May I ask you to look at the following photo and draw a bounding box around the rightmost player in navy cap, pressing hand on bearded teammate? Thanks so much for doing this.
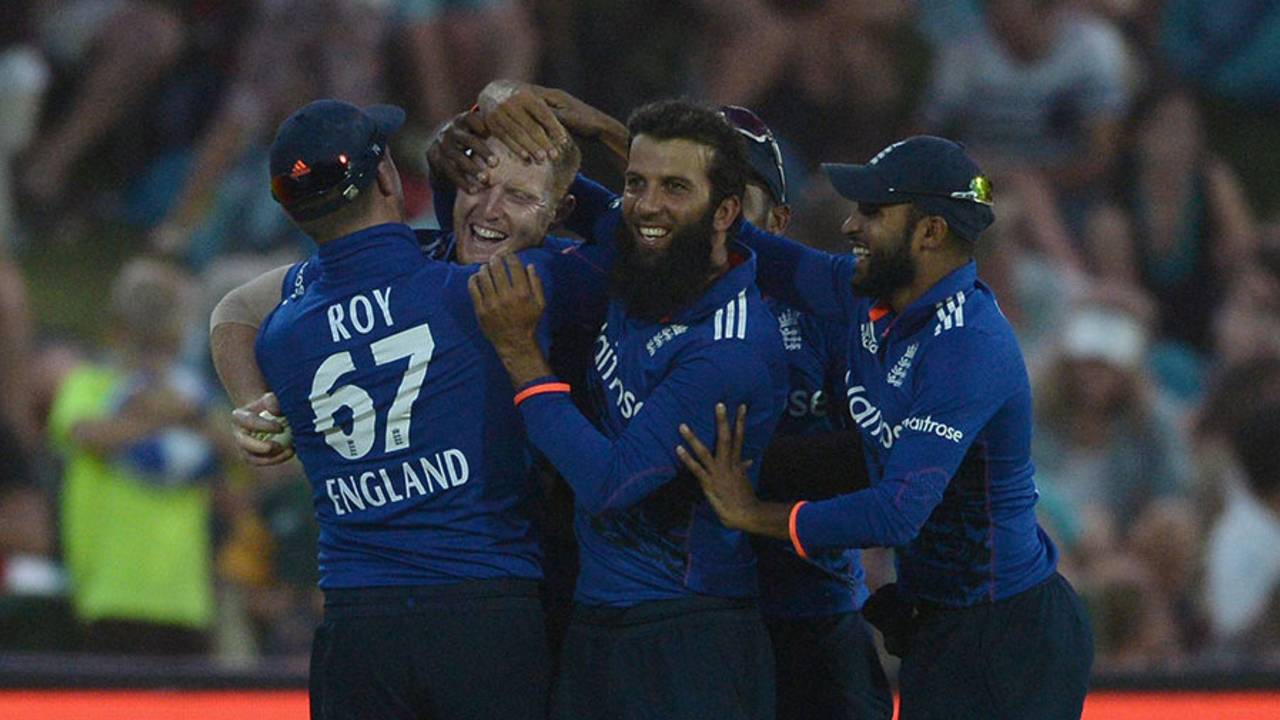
[680,136,1093,720]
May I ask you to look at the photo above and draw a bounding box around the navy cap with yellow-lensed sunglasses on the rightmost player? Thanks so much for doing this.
[822,135,996,241]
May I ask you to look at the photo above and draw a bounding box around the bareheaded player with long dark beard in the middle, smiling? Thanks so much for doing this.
[471,101,786,720]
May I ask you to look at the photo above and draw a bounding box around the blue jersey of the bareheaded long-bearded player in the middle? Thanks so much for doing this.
[521,179,786,607]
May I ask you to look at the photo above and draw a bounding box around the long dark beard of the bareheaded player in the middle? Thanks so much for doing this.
[609,210,716,323]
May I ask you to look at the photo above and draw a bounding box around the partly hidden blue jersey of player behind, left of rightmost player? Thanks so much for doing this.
[755,297,868,619]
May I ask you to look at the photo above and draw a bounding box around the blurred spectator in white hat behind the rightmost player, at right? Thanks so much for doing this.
[1032,291,1185,560]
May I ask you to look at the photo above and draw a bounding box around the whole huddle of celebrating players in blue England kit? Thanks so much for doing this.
[210,82,1092,720]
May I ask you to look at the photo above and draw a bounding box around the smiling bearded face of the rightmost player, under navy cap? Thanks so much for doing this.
[840,202,923,299]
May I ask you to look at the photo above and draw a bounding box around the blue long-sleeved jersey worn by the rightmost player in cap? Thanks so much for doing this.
[741,221,1056,607]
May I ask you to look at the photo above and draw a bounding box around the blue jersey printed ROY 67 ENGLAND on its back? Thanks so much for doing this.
[256,224,598,588]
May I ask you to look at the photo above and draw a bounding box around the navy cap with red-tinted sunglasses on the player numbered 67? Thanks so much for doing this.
[270,100,404,220]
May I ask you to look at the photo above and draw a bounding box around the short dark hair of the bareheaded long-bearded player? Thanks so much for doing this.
[627,100,750,209]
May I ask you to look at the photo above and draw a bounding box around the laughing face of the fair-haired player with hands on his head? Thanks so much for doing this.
[453,138,559,264]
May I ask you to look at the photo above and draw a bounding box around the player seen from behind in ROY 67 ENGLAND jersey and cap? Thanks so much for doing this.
[256,100,604,719]
